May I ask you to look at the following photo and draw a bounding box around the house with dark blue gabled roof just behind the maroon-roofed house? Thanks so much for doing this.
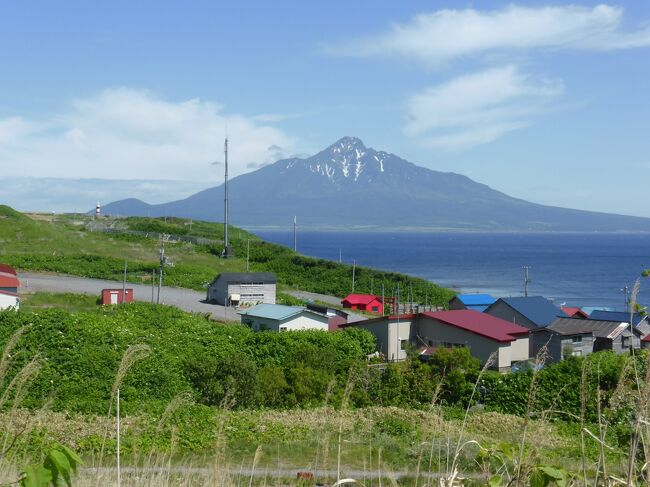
[485,296,567,329]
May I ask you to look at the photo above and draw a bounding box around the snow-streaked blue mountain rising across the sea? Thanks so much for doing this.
[104,137,650,231]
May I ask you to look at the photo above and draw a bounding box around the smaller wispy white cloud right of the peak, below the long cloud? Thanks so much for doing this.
[404,66,563,149]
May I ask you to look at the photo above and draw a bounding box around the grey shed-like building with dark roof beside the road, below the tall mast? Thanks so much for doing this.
[207,272,277,306]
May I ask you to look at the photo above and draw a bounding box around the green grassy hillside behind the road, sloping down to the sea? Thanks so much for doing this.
[0,206,453,305]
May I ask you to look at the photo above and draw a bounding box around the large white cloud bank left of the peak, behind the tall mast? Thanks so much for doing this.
[0,88,294,181]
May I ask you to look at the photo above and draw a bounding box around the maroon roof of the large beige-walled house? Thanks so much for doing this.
[422,309,529,342]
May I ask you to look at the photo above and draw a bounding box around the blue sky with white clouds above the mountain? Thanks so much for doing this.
[0,1,650,217]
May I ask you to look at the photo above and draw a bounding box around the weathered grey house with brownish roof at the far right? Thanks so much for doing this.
[530,318,641,362]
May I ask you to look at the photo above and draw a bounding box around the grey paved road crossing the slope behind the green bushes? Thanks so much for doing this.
[18,272,239,321]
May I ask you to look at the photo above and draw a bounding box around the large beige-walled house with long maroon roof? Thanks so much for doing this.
[347,310,529,371]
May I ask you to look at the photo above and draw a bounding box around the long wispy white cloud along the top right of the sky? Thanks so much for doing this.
[327,5,650,65]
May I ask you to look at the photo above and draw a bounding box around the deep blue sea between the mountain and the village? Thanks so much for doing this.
[255,231,650,310]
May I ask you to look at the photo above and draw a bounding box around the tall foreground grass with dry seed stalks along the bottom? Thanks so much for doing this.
[0,336,650,487]
